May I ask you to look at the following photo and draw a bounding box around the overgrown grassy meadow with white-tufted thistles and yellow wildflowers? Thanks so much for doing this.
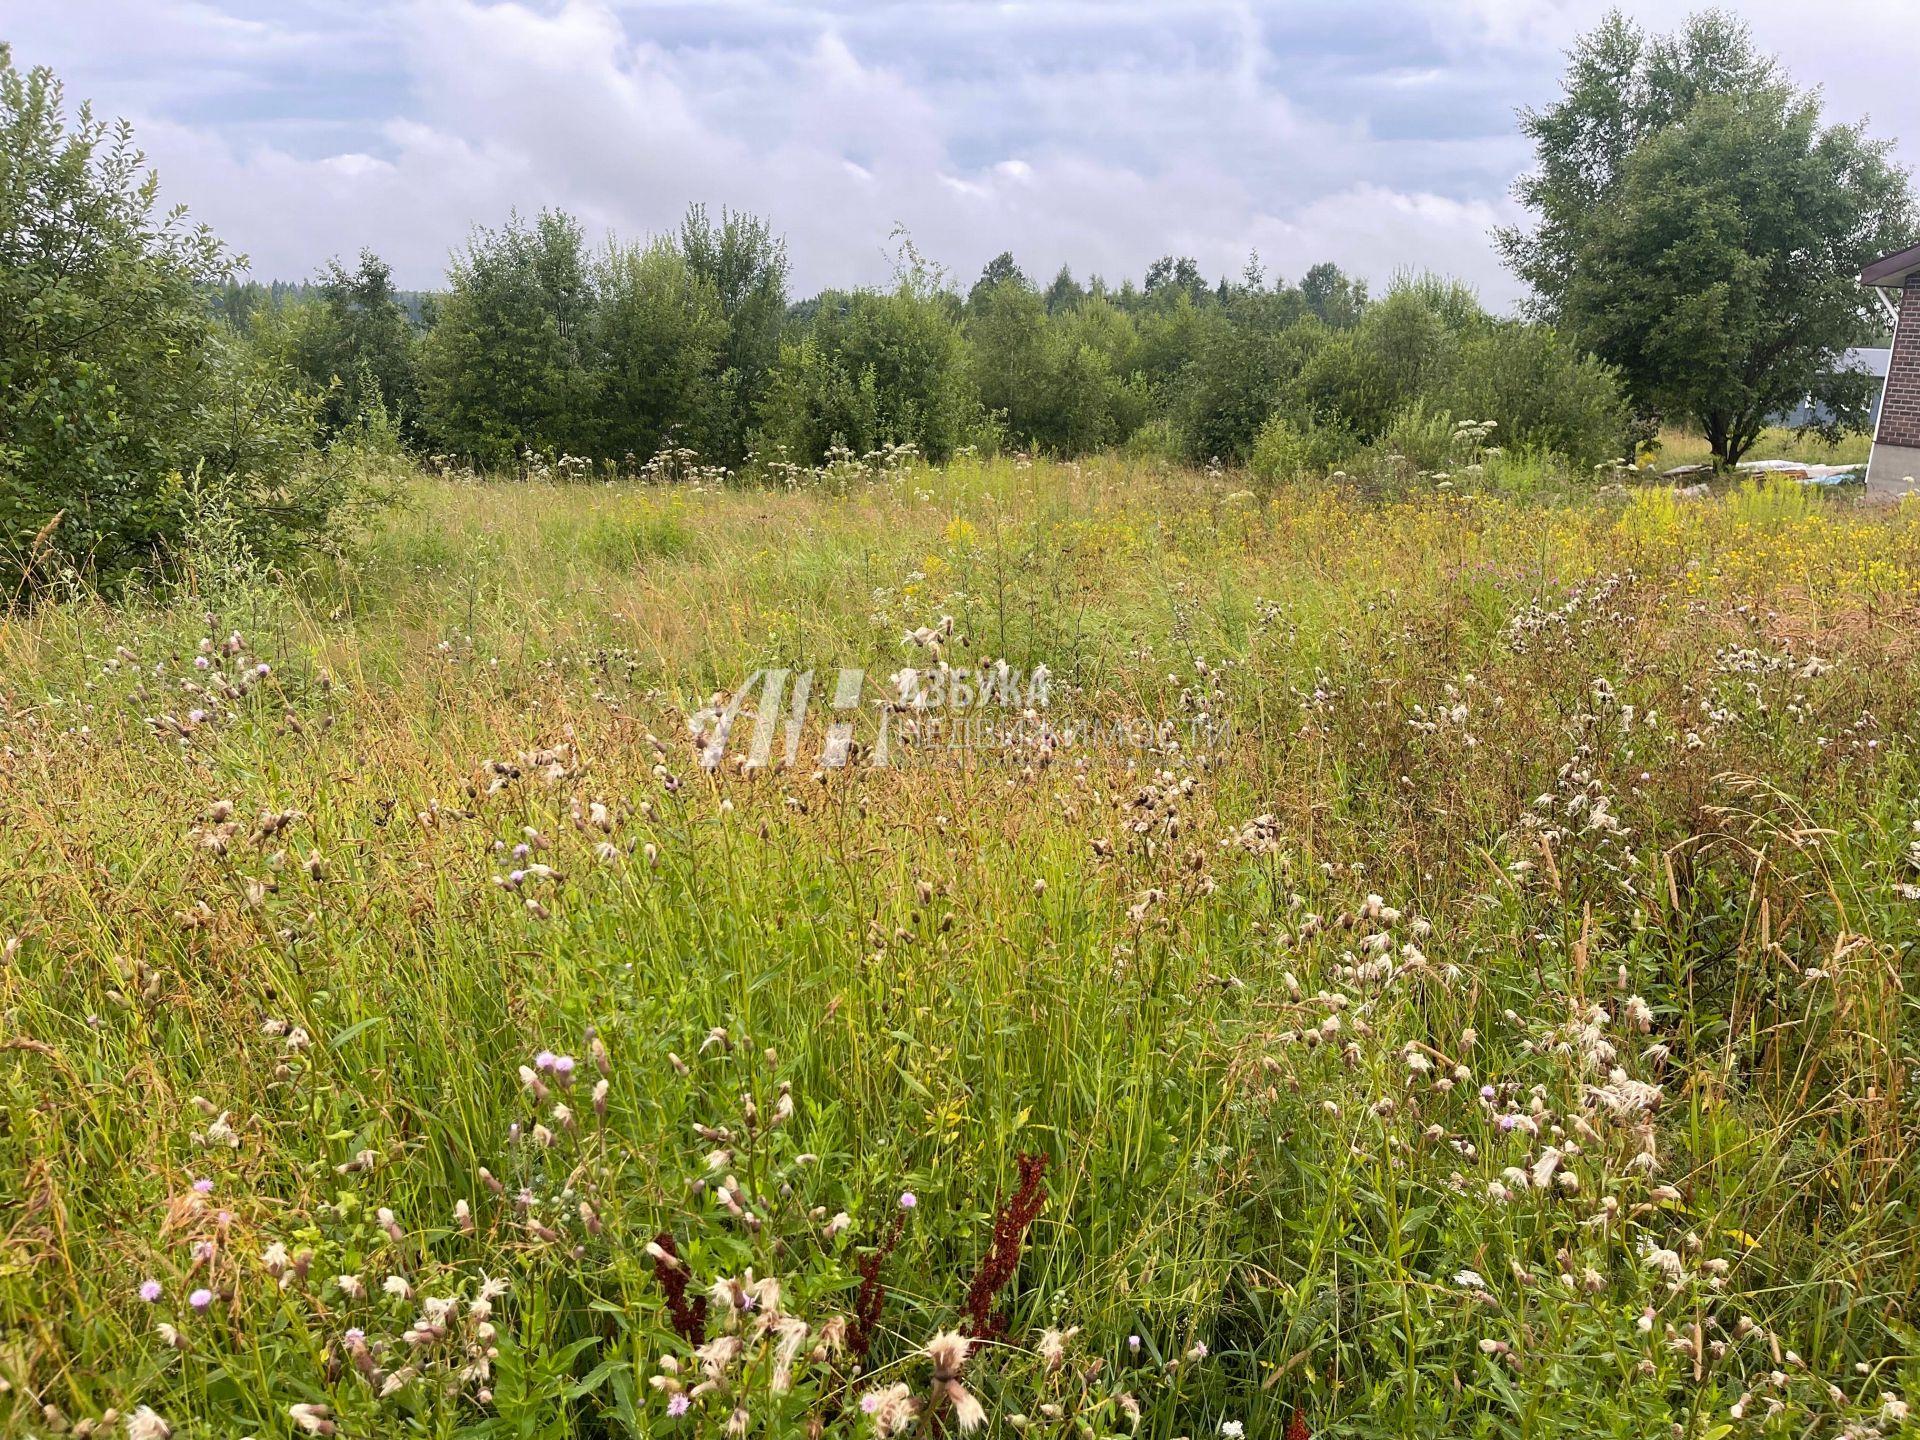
[0,461,1920,1440]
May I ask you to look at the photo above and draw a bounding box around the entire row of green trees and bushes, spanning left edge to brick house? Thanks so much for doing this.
[0,12,1914,582]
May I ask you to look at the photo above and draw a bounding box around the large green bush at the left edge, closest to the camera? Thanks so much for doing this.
[0,46,366,589]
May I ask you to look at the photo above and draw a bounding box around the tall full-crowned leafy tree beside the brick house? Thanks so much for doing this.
[1500,12,1912,465]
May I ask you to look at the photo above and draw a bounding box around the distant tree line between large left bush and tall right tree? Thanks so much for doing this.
[228,205,1626,480]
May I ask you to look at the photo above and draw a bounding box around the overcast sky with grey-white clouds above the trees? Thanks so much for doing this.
[0,0,1920,307]
